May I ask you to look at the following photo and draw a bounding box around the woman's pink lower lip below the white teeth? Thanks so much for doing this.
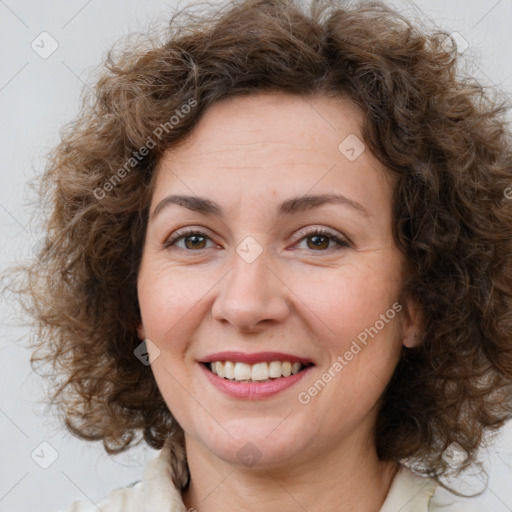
[199,363,313,400]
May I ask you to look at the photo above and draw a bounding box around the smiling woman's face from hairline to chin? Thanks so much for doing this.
[138,93,416,467]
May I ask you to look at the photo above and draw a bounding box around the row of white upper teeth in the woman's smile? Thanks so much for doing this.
[209,361,303,382]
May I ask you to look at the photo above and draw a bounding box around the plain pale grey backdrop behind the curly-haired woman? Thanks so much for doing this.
[0,0,512,512]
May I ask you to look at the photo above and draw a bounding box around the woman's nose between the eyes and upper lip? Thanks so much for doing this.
[212,242,290,333]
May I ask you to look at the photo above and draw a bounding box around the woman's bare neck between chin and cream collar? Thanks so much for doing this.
[183,439,399,512]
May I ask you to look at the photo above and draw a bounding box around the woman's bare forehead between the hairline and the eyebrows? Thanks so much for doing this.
[153,93,389,213]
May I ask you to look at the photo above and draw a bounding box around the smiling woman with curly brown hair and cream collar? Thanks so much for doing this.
[7,0,512,512]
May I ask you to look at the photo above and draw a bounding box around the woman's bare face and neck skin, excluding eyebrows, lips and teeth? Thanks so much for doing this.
[138,93,418,512]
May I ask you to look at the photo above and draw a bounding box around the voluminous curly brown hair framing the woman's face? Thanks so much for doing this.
[4,0,512,492]
